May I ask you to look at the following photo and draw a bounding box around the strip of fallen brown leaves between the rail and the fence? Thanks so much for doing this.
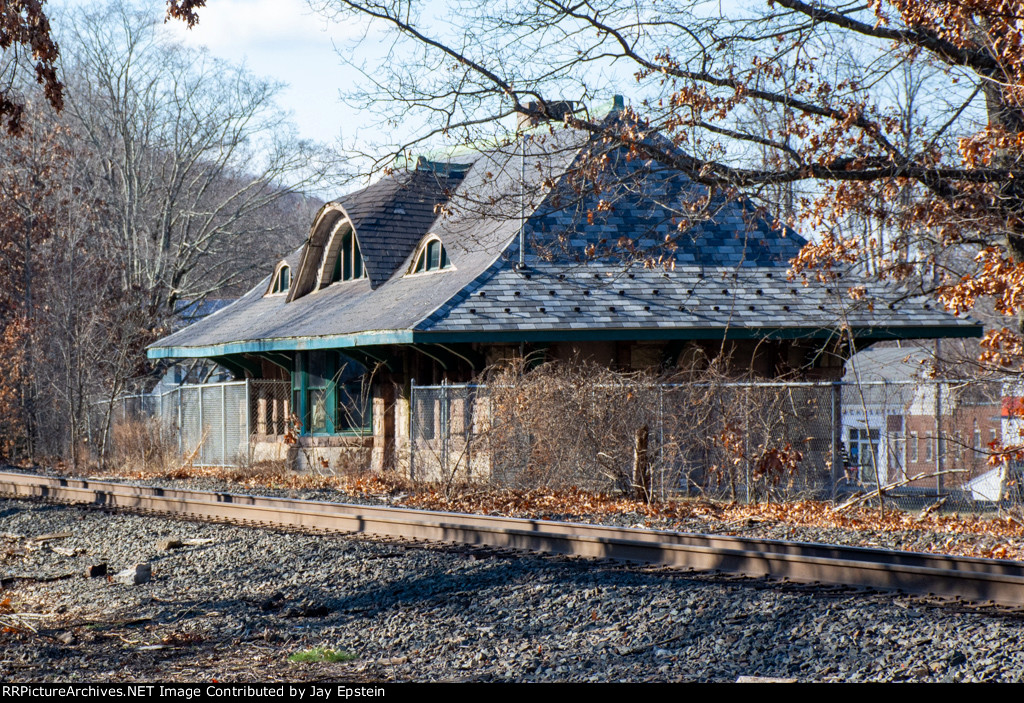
[41,467,1024,561]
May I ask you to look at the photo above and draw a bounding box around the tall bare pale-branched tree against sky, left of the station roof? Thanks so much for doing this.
[58,4,338,316]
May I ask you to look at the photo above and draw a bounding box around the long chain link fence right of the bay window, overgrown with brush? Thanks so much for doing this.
[411,376,1024,512]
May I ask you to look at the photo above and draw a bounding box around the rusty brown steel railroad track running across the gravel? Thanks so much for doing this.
[0,472,1024,608]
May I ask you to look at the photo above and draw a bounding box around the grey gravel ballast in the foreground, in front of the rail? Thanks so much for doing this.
[0,499,1024,682]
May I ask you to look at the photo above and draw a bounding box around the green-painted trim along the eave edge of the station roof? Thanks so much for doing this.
[146,324,983,359]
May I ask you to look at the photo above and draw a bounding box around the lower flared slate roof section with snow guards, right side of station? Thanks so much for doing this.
[418,262,971,335]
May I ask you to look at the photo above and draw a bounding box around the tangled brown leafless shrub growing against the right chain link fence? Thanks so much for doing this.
[475,362,830,502]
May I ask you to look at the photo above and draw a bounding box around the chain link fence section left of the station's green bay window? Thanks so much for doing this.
[89,381,291,467]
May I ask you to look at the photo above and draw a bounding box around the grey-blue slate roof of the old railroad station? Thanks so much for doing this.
[150,120,980,357]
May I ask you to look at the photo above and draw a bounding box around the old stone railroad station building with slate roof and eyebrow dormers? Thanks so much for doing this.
[148,100,981,469]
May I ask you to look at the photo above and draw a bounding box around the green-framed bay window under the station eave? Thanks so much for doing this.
[292,351,373,435]
